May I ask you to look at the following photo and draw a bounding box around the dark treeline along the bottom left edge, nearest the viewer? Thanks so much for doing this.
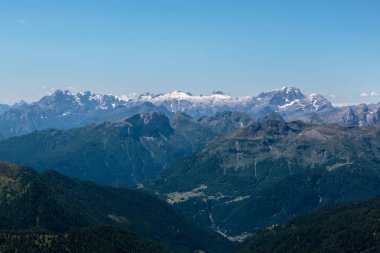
[0,226,167,253]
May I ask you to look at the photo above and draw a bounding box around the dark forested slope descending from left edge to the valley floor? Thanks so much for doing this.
[0,163,231,252]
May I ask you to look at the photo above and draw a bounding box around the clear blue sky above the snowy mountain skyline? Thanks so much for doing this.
[0,0,380,104]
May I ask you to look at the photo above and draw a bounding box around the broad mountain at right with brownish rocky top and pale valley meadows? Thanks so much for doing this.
[148,114,380,240]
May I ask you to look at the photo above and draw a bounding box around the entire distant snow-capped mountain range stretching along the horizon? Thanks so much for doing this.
[0,87,380,138]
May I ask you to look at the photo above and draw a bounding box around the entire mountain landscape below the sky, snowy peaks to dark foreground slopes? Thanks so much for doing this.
[0,87,380,252]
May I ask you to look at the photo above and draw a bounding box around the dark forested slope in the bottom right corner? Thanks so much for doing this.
[239,197,380,253]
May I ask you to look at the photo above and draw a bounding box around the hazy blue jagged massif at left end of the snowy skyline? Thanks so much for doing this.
[0,90,170,138]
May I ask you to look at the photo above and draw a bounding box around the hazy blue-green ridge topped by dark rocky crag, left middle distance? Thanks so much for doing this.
[0,112,221,186]
